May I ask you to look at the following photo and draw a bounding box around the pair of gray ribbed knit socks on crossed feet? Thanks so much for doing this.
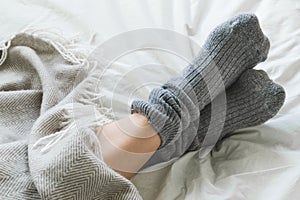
[132,14,285,164]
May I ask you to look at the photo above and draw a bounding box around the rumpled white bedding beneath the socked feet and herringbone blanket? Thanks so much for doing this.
[0,0,300,200]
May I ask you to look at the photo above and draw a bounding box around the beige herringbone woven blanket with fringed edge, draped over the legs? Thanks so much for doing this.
[0,33,141,200]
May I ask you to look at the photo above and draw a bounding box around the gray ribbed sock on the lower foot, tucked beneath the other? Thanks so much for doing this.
[187,69,285,152]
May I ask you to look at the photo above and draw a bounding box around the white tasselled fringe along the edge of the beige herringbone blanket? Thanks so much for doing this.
[4,28,115,153]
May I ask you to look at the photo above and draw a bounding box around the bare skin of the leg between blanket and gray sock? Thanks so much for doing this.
[97,114,161,179]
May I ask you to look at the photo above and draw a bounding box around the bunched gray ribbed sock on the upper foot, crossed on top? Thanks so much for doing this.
[132,14,269,155]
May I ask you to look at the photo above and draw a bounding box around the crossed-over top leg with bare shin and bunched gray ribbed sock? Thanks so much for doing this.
[98,15,279,177]
